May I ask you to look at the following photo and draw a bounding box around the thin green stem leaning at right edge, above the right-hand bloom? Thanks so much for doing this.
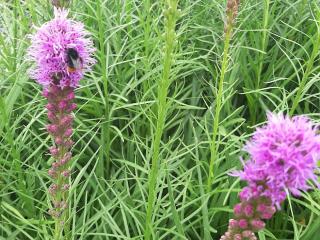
[289,5,320,116]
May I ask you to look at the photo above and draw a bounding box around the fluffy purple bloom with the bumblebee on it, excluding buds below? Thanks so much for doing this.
[28,8,95,89]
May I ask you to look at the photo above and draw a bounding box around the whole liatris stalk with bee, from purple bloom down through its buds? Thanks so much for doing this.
[28,9,94,240]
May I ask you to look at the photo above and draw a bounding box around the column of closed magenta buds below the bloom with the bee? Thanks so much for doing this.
[43,84,76,218]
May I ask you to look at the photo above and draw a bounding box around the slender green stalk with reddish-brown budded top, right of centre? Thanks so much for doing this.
[207,0,240,192]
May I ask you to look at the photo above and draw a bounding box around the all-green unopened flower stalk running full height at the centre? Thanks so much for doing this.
[144,0,179,240]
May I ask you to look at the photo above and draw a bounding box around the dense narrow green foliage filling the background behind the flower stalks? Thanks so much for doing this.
[0,0,320,240]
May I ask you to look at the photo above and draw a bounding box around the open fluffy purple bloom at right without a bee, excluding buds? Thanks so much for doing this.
[239,113,320,204]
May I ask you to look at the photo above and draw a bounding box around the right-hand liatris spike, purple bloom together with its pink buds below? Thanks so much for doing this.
[221,113,320,240]
